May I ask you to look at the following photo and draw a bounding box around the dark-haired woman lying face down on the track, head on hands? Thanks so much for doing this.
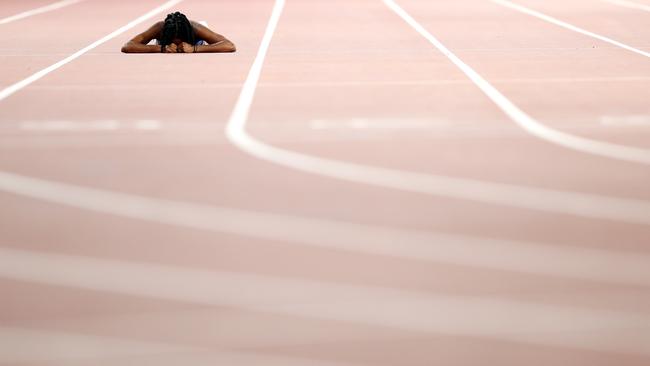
[122,12,235,53]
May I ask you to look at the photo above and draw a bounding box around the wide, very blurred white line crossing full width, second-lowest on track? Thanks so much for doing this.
[0,248,650,355]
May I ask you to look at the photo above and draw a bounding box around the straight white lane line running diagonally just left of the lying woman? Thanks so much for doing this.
[0,0,183,101]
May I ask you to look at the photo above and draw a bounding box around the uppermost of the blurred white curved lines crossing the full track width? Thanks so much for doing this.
[0,172,650,286]
